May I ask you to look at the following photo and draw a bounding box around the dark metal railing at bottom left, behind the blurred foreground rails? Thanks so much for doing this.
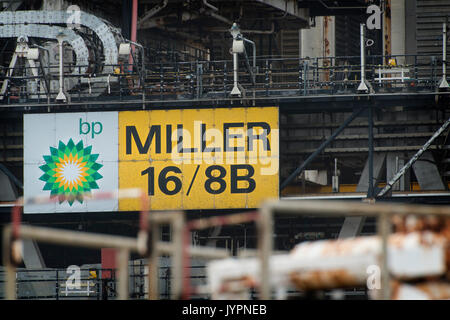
[0,261,208,300]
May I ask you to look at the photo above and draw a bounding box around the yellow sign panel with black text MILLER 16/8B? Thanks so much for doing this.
[119,107,279,211]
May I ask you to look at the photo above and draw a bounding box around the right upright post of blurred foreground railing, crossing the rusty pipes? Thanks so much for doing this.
[378,212,391,300]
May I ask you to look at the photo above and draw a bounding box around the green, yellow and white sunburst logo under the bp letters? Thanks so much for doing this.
[39,139,103,206]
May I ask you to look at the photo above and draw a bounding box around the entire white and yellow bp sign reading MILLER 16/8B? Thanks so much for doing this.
[24,107,279,213]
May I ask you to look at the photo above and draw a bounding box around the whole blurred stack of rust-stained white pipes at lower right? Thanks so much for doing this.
[208,217,450,299]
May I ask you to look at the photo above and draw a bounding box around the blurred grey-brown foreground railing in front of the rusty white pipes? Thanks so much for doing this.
[258,200,450,299]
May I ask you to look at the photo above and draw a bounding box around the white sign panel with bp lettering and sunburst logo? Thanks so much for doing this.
[23,112,118,213]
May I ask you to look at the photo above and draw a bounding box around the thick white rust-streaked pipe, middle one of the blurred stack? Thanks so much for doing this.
[208,231,448,294]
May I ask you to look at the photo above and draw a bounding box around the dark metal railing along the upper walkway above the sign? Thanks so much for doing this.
[0,55,442,104]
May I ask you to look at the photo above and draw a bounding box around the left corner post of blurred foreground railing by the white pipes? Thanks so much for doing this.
[258,205,273,300]
